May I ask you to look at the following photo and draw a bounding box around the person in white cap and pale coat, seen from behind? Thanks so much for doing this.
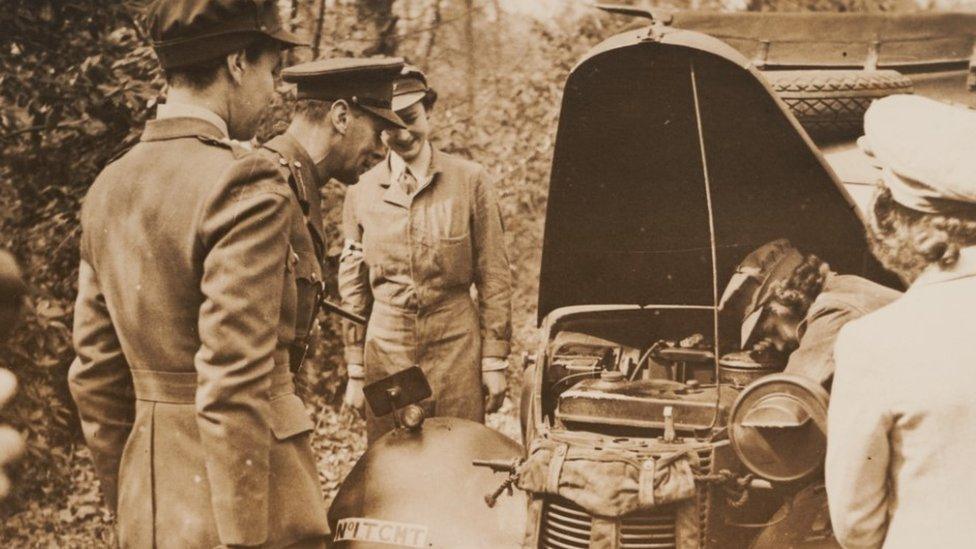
[825,95,976,548]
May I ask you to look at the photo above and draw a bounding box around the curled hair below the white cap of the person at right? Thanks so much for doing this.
[868,187,976,283]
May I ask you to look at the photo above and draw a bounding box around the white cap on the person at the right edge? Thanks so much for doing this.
[859,95,976,213]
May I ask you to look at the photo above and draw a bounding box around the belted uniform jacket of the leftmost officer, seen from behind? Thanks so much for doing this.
[69,117,327,548]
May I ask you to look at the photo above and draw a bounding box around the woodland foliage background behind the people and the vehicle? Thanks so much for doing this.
[0,0,954,547]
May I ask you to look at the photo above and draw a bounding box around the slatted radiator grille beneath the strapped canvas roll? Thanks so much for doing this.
[539,497,676,549]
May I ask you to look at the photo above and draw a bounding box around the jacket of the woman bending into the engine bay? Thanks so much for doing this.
[785,273,901,385]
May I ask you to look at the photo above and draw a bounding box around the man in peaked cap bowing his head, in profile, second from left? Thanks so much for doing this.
[263,58,403,369]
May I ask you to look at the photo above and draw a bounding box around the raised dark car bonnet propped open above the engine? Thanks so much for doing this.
[539,25,879,321]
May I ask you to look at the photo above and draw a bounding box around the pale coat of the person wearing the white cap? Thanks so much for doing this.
[825,247,976,548]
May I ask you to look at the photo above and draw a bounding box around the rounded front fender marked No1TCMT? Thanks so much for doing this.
[329,417,527,549]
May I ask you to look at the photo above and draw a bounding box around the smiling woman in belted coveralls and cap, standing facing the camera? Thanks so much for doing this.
[339,67,512,442]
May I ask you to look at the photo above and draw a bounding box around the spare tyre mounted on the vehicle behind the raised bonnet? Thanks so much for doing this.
[764,70,912,141]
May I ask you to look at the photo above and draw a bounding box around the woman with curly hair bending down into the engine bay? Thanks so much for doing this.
[722,239,901,388]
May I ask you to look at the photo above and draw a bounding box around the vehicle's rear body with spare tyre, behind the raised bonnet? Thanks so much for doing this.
[671,11,976,211]
